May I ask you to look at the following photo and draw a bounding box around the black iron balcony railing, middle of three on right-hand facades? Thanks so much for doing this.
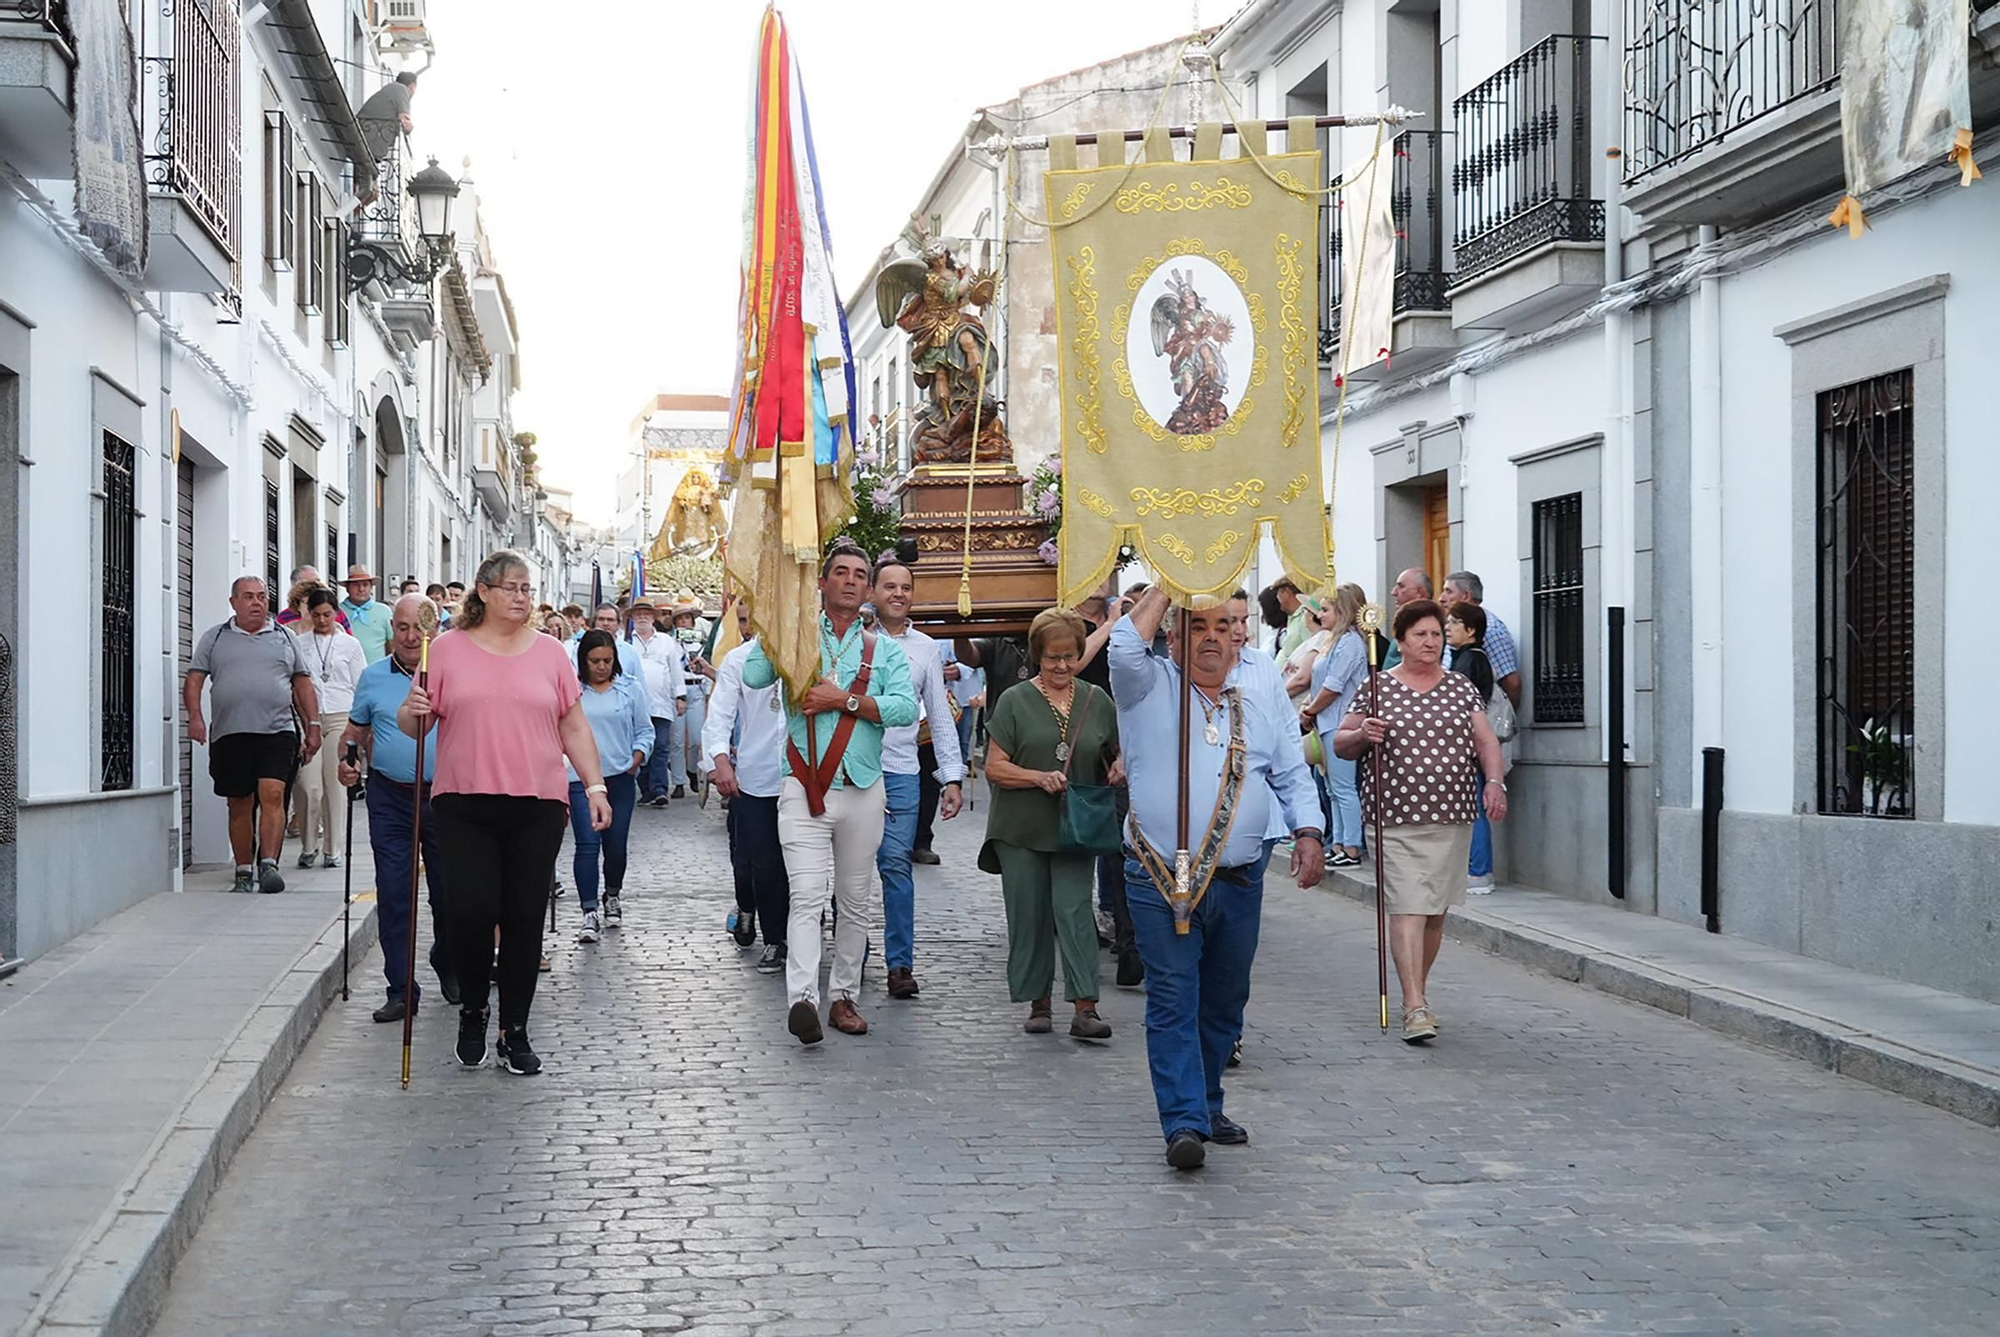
[1452,34,1604,282]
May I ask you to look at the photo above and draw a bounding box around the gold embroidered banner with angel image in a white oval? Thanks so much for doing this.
[1044,120,1330,606]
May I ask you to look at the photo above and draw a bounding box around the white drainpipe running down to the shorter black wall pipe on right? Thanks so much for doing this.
[1688,226,1722,793]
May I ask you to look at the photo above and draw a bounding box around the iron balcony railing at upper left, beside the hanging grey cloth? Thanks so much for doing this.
[144,0,242,260]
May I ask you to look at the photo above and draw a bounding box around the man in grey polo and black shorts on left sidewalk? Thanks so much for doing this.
[182,576,320,893]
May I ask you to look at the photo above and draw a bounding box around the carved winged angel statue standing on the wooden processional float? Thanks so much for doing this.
[876,238,1014,464]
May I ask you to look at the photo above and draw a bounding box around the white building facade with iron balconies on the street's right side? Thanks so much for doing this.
[1212,0,2000,1001]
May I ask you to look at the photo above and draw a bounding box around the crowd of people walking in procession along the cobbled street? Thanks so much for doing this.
[186,540,1520,1169]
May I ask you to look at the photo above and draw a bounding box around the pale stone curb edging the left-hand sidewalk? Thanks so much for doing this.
[22,903,378,1337]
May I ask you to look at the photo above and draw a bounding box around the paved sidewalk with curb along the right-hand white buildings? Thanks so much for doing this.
[1324,867,2000,1127]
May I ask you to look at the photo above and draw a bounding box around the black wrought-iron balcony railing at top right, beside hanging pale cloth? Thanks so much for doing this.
[1618,0,1840,180]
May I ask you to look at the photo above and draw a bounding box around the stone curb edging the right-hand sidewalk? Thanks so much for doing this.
[1322,869,2000,1127]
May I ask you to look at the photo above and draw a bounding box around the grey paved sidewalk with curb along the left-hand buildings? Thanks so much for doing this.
[0,833,380,1333]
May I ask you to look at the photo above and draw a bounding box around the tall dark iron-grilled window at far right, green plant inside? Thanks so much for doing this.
[1816,368,1916,817]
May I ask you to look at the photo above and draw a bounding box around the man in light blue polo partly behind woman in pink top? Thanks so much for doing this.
[340,594,458,1021]
